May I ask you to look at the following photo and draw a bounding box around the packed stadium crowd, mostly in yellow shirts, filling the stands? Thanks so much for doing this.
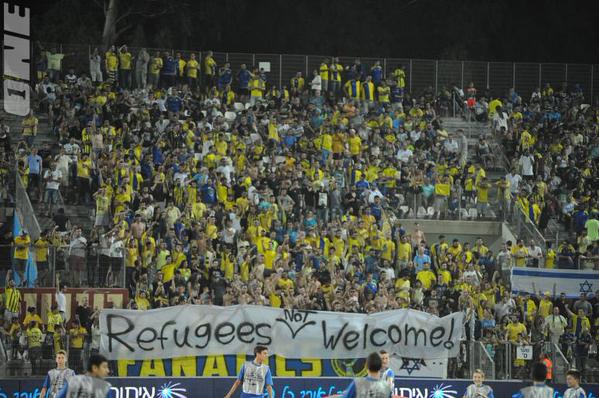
[0,46,599,380]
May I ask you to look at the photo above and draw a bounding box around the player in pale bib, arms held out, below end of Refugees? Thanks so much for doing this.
[225,345,274,398]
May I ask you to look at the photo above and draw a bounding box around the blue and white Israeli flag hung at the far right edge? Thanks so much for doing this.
[512,267,599,298]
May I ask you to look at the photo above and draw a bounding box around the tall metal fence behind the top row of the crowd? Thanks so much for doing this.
[42,43,599,100]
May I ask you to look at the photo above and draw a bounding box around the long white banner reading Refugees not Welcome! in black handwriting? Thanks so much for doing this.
[100,305,464,359]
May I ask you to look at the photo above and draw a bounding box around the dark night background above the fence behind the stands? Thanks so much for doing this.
[19,0,599,63]
